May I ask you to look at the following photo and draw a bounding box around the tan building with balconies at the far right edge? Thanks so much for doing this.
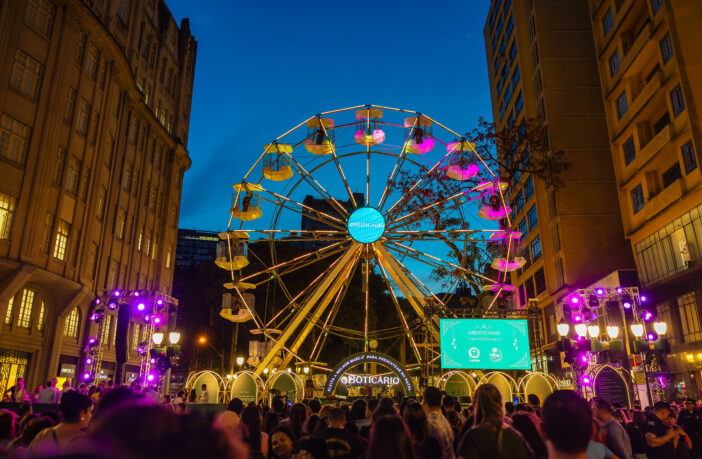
[589,0,702,398]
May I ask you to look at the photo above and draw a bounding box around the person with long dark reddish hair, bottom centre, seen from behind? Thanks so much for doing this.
[368,416,417,459]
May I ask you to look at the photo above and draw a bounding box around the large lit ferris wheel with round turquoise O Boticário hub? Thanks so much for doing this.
[216,105,526,375]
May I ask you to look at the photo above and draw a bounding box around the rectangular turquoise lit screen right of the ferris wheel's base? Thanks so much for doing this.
[439,319,531,370]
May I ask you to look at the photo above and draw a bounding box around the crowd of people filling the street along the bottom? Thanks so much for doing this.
[0,380,702,459]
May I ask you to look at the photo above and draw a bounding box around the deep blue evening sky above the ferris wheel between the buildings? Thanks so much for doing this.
[167,0,492,230]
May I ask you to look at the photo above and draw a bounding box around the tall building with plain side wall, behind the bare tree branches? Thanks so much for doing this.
[484,0,633,371]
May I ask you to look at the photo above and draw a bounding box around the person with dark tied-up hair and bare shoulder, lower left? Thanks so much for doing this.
[29,391,93,455]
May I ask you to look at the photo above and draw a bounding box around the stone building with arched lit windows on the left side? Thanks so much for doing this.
[0,0,197,392]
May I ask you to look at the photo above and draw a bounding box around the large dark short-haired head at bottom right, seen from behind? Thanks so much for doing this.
[541,390,592,454]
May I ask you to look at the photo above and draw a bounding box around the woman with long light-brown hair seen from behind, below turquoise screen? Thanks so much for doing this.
[456,384,533,459]
